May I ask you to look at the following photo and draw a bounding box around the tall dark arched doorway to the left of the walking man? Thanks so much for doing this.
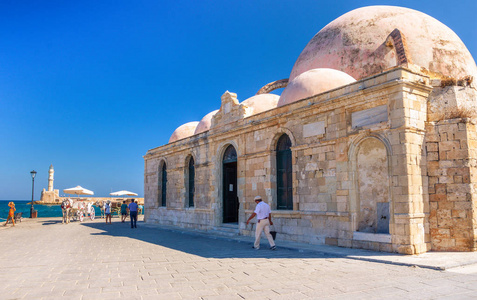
[222,145,239,223]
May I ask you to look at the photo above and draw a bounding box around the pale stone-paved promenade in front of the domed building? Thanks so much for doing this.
[0,218,477,300]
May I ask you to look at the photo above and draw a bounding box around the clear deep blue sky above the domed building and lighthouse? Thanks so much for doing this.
[0,0,477,200]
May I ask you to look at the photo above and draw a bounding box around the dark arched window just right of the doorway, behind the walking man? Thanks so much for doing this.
[277,134,293,210]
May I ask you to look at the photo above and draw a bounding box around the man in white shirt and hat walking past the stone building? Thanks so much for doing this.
[247,196,276,250]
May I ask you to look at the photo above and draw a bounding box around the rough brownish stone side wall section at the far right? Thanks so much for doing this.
[426,119,477,251]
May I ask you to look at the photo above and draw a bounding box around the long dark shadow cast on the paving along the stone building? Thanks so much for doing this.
[77,221,398,259]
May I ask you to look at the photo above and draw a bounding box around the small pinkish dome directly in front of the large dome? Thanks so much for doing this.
[278,69,356,106]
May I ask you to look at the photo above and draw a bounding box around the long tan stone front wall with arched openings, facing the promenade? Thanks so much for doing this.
[144,68,452,254]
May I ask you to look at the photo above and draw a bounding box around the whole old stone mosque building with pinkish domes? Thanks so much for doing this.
[144,6,477,254]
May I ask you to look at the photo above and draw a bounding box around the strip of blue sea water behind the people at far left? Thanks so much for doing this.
[0,200,101,221]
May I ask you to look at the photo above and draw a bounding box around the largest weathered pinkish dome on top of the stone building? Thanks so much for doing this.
[290,6,477,80]
